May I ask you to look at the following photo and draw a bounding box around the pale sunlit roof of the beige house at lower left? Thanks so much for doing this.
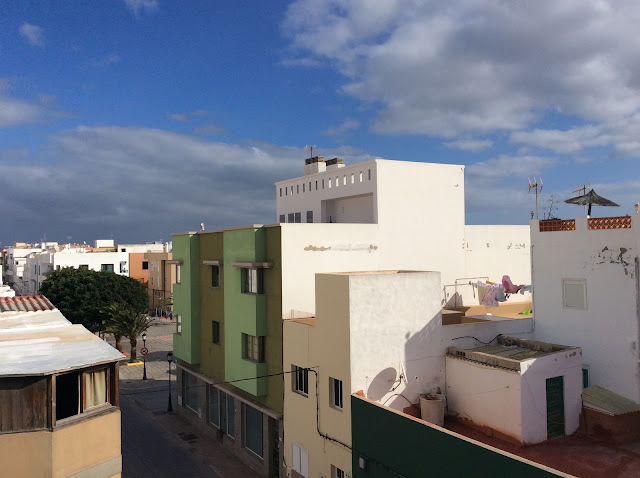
[0,302,125,377]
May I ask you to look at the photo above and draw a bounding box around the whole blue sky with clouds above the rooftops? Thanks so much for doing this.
[0,0,640,246]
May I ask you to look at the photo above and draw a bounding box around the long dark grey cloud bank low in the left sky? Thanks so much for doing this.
[0,126,371,241]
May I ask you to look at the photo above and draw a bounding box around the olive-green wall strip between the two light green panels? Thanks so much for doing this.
[198,231,225,382]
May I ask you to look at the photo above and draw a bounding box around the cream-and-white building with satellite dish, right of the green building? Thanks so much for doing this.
[283,271,533,478]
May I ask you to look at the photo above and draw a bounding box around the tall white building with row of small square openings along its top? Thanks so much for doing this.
[276,157,531,305]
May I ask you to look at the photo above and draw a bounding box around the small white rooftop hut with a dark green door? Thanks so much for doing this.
[446,336,582,445]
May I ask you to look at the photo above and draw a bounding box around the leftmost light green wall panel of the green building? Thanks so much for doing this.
[172,233,200,365]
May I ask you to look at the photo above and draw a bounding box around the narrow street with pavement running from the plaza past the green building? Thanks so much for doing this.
[113,319,257,478]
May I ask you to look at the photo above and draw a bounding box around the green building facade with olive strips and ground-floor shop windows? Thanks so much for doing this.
[173,226,284,476]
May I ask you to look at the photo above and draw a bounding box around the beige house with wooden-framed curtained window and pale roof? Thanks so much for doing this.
[0,296,124,478]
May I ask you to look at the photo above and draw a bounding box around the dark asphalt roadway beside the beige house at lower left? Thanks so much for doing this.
[120,395,221,478]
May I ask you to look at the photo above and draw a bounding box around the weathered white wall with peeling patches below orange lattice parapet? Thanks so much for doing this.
[531,215,640,402]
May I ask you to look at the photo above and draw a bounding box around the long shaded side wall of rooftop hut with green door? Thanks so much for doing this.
[446,356,524,441]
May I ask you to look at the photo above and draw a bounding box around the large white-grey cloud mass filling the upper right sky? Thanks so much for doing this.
[282,0,640,138]
